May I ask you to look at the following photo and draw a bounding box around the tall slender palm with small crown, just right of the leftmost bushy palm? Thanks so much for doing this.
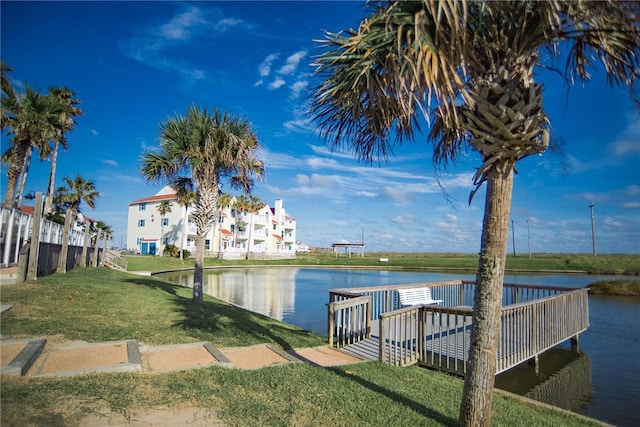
[44,87,83,213]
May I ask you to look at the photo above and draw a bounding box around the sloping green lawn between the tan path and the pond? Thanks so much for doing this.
[2,267,326,349]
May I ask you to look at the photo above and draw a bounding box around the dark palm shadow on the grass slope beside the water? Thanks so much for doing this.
[124,278,317,350]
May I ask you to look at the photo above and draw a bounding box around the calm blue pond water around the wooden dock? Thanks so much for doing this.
[162,267,640,426]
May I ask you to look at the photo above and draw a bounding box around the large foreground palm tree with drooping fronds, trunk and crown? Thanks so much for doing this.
[311,0,640,426]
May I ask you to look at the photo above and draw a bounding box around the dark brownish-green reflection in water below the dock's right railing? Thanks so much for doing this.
[496,347,593,412]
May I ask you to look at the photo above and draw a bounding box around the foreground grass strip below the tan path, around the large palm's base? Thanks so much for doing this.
[2,362,597,427]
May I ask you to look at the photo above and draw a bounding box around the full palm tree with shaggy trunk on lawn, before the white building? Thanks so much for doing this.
[141,106,264,303]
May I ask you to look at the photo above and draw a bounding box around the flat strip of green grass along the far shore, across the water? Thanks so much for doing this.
[124,252,640,275]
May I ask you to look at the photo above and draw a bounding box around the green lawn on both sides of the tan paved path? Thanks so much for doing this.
[0,268,596,426]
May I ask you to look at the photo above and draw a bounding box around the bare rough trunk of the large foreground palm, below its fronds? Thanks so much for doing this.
[460,161,514,427]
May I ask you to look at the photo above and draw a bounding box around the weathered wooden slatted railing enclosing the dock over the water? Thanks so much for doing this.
[328,280,589,375]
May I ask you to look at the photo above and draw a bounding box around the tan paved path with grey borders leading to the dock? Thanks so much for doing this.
[0,337,363,377]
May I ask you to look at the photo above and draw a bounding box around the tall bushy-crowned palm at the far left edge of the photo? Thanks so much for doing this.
[2,86,62,206]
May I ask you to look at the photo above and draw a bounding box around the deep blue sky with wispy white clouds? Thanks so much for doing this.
[0,1,640,254]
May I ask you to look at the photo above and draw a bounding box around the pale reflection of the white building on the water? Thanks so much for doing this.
[163,268,298,321]
